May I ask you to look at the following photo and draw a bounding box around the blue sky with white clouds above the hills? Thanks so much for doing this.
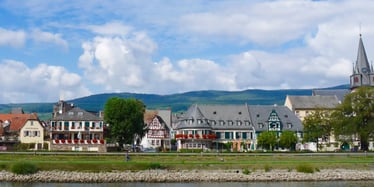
[0,0,374,104]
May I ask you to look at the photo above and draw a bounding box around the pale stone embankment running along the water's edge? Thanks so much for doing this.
[0,169,374,183]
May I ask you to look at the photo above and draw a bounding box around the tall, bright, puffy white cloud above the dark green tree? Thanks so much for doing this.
[79,33,156,91]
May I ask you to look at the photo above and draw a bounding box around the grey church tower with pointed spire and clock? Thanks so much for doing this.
[350,34,374,90]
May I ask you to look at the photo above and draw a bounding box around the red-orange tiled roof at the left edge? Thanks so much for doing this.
[0,113,38,131]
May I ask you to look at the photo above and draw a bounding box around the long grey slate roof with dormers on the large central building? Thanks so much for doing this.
[176,104,302,131]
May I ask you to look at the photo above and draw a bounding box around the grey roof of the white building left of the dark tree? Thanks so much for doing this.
[52,107,103,121]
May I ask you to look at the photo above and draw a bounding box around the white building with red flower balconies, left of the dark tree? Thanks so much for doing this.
[49,101,106,152]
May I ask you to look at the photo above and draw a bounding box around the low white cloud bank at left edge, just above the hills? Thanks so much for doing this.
[0,60,90,103]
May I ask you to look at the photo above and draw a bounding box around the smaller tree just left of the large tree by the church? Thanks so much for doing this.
[303,109,331,151]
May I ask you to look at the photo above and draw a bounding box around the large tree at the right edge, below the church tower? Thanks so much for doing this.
[332,87,374,151]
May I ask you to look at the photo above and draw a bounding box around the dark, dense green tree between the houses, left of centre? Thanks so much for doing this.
[104,97,147,148]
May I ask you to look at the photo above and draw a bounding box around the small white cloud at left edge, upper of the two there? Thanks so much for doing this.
[0,28,26,47]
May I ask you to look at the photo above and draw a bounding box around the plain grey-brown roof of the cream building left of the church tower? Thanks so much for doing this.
[287,95,339,109]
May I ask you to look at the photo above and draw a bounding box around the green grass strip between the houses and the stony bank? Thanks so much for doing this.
[0,153,374,172]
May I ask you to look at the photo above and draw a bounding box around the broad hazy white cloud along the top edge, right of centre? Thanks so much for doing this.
[178,1,336,46]
